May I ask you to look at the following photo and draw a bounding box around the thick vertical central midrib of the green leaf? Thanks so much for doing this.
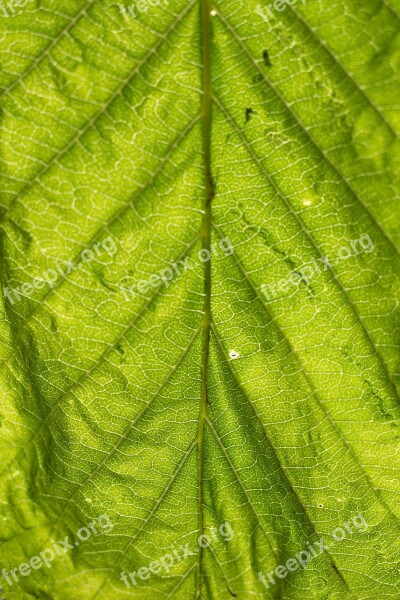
[196,0,214,598]
